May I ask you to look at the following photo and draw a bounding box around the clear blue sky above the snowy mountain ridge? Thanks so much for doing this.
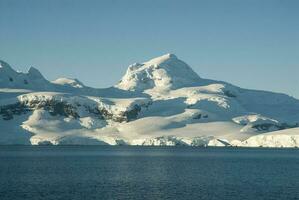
[0,0,299,98]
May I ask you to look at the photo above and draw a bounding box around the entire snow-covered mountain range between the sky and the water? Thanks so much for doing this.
[0,54,299,147]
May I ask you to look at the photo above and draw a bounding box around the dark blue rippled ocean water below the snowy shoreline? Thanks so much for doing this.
[0,146,299,200]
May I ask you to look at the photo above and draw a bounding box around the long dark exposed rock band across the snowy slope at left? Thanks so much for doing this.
[0,95,150,122]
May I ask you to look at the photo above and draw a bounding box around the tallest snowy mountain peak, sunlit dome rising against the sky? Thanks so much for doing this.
[116,54,201,91]
